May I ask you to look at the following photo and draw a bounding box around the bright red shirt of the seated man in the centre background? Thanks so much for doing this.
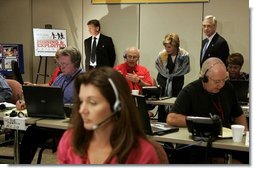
[114,62,153,93]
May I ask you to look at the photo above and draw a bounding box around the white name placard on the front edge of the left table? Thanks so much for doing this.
[4,117,27,130]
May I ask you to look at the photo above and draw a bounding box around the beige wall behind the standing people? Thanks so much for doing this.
[0,0,251,163]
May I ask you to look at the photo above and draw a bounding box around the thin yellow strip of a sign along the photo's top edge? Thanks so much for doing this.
[92,0,209,4]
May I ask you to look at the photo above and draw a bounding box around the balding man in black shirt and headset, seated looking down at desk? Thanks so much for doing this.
[167,57,249,163]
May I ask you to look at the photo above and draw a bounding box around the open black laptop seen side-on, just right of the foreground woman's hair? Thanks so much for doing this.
[133,95,179,135]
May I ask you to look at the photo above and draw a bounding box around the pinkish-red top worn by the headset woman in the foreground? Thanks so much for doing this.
[57,129,160,164]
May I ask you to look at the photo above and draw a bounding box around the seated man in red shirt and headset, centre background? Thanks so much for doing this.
[114,47,153,93]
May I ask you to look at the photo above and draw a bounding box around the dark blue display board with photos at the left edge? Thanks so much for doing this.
[0,43,24,75]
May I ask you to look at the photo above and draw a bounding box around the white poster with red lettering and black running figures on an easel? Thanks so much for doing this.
[33,28,67,57]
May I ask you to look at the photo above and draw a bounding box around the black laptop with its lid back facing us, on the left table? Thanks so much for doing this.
[23,86,65,119]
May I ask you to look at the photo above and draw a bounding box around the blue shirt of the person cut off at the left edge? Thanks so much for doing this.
[0,74,12,102]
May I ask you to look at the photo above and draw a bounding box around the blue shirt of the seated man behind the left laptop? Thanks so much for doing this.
[51,68,83,104]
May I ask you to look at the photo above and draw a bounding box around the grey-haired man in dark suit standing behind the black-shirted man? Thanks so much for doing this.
[200,15,229,67]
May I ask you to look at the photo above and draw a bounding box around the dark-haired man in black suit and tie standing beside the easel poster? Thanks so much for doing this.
[84,19,116,71]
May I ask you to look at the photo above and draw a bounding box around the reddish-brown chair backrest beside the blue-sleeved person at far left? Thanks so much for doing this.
[6,79,23,104]
